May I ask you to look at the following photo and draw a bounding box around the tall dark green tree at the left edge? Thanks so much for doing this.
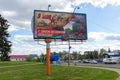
[0,15,12,61]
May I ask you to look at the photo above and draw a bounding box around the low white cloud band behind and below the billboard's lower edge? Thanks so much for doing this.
[12,32,120,54]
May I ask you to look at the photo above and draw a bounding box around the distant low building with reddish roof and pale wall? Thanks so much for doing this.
[10,55,28,61]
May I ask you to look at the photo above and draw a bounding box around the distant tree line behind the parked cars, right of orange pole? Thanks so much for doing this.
[50,48,108,61]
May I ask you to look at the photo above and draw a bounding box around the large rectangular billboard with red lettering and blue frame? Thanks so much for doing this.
[33,10,87,40]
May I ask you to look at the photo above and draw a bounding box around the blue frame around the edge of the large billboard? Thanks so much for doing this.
[32,10,88,40]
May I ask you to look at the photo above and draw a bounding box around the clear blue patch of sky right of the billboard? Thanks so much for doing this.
[79,4,120,33]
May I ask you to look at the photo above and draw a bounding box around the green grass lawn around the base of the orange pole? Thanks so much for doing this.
[0,62,119,80]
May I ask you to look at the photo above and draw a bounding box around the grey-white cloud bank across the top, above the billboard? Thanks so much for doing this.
[0,0,120,31]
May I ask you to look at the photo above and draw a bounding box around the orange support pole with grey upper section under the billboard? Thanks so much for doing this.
[45,39,52,76]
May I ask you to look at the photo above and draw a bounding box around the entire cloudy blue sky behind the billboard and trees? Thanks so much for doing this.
[0,0,120,55]
